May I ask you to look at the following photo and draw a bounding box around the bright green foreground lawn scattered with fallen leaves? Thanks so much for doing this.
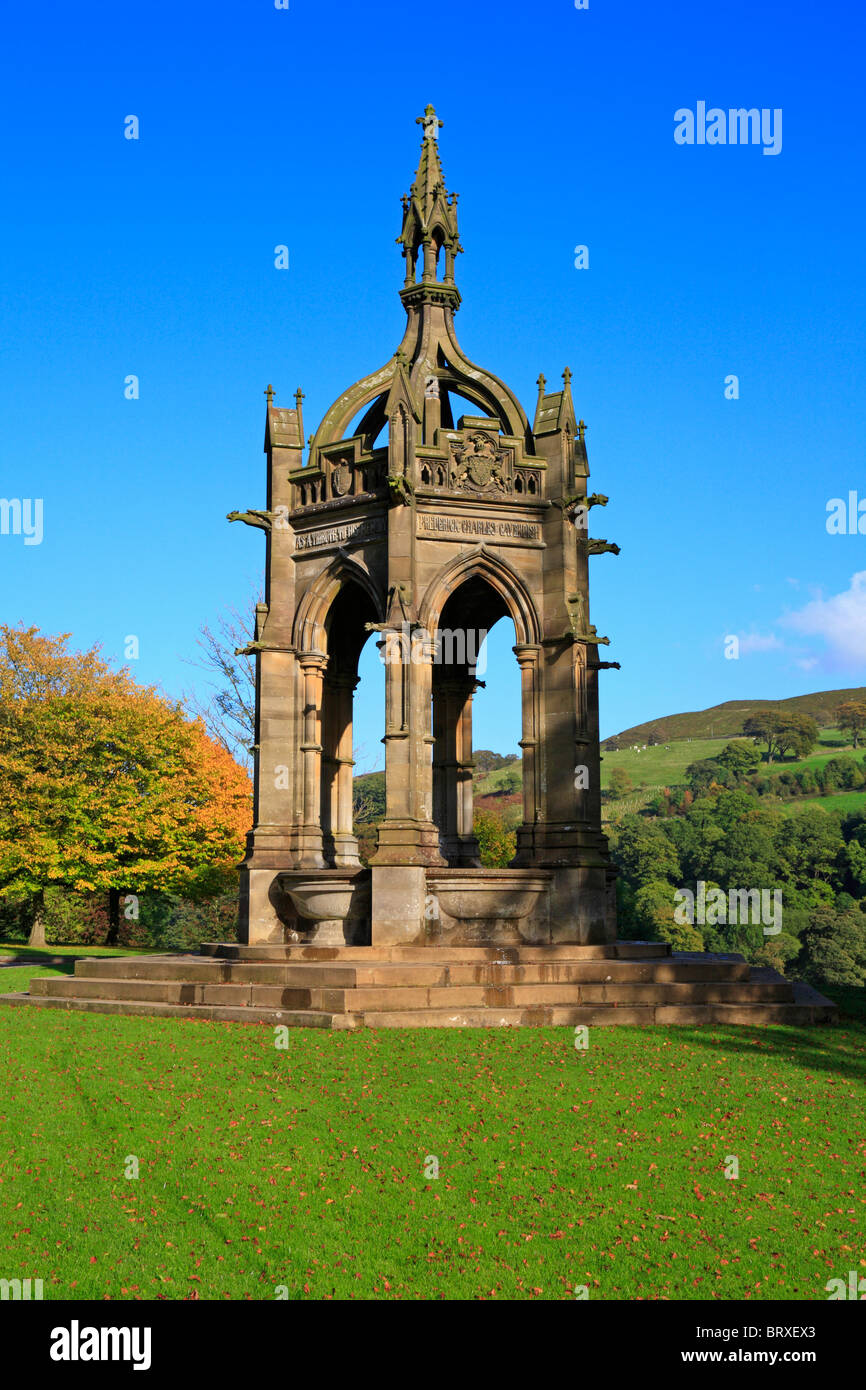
[0,991,866,1300]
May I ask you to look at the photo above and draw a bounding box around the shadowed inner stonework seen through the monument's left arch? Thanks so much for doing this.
[320,581,377,869]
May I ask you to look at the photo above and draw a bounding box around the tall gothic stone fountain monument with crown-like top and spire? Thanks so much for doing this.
[233,108,616,947]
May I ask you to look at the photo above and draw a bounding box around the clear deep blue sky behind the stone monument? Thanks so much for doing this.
[0,0,866,767]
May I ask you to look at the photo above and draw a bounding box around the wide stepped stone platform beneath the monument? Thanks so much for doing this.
[0,941,837,1029]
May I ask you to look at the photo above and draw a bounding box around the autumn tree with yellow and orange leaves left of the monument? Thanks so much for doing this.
[0,626,252,944]
